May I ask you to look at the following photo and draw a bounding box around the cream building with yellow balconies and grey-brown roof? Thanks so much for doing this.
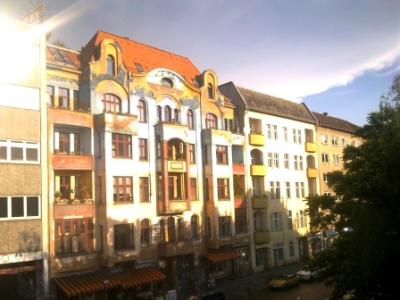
[220,82,318,270]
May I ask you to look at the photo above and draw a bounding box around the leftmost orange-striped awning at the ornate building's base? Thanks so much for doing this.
[55,272,118,297]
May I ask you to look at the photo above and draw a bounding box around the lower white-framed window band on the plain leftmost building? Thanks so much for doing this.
[0,196,41,219]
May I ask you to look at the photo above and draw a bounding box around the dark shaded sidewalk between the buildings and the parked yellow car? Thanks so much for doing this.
[216,261,305,300]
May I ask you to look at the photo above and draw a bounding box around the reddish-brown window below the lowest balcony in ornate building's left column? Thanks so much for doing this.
[55,219,93,255]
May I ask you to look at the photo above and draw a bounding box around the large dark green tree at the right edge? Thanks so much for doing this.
[307,74,400,299]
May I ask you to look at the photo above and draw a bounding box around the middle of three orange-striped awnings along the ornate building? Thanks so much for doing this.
[114,267,167,289]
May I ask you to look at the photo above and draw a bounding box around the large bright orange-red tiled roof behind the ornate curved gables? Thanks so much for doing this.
[82,31,200,83]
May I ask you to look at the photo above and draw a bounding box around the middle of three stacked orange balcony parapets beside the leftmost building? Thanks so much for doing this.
[52,154,93,171]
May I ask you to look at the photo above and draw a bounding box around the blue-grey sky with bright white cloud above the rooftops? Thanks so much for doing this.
[0,0,400,125]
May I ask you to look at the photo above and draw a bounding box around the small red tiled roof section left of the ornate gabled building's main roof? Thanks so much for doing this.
[46,45,81,70]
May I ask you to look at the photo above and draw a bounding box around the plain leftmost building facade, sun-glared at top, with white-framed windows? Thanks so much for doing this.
[0,18,47,299]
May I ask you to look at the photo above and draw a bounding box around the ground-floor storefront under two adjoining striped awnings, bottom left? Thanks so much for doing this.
[55,267,166,300]
